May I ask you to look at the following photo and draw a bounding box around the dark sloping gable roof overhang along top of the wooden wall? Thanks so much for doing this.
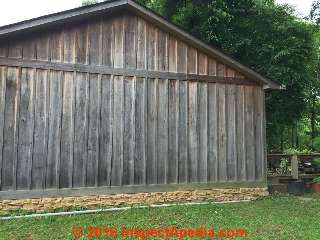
[0,0,284,89]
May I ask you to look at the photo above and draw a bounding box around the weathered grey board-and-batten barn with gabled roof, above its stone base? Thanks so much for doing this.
[0,0,280,199]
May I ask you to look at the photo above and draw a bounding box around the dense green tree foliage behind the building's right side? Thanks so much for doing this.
[140,0,320,151]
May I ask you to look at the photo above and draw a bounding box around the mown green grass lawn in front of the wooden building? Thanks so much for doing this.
[0,195,320,240]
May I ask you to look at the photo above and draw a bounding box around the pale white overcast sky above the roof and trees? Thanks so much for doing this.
[0,0,312,26]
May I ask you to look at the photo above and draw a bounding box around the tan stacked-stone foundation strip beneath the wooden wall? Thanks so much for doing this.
[0,188,269,212]
